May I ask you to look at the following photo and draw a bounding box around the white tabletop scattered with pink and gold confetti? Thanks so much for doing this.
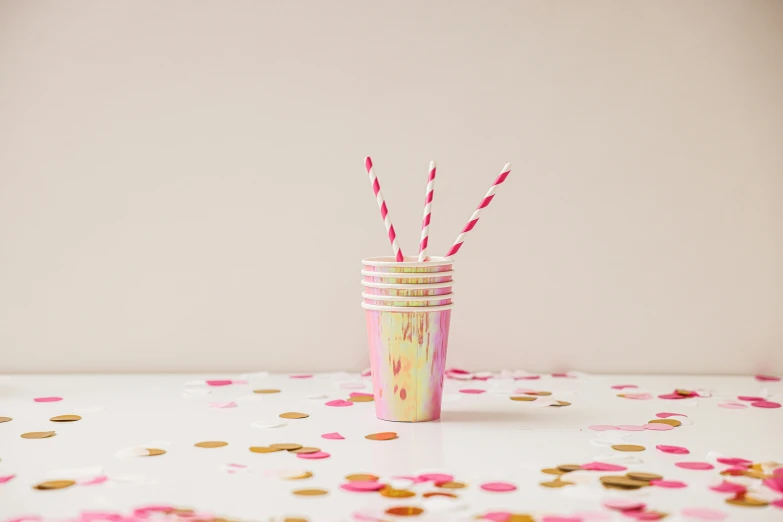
[0,372,783,522]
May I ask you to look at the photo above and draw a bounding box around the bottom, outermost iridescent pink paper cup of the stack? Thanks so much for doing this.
[362,303,454,422]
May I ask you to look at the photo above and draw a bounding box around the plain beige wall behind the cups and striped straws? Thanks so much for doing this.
[0,0,783,373]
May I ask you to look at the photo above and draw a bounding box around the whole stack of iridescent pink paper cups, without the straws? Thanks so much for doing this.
[362,257,454,422]
